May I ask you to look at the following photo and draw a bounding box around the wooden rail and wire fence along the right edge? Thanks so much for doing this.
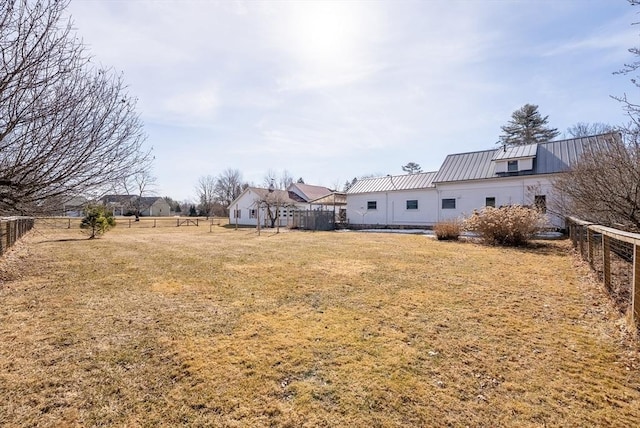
[567,217,640,325]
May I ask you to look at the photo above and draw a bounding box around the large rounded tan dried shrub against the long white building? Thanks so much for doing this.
[465,205,546,246]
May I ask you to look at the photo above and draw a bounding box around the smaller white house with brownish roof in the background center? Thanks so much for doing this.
[229,183,331,226]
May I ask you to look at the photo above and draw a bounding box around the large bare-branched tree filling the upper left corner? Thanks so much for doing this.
[0,0,150,213]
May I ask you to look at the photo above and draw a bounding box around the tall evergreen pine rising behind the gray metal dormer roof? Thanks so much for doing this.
[498,104,560,146]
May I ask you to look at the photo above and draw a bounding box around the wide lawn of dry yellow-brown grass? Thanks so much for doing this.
[0,222,640,427]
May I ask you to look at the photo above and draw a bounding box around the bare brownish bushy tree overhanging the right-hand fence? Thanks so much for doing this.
[554,132,640,230]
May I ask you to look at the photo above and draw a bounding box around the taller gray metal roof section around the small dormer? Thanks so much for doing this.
[433,134,620,183]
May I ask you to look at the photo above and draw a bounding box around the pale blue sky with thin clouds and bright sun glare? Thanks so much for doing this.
[68,0,640,201]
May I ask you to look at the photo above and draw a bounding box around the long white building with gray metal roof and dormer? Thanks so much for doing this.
[347,134,618,227]
